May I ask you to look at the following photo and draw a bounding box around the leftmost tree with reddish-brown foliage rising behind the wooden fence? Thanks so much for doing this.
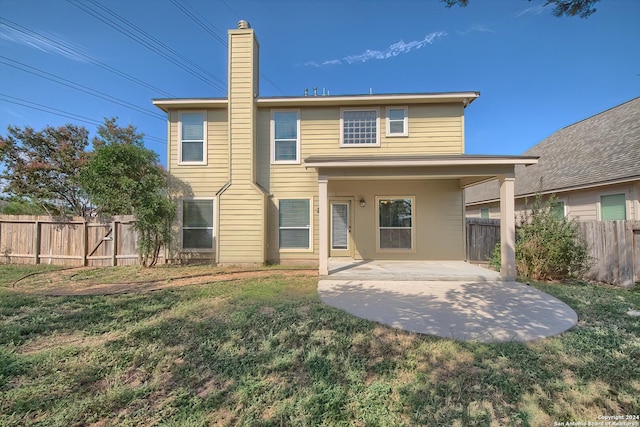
[0,124,89,216]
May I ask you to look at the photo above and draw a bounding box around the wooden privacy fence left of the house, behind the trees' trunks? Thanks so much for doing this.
[0,215,162,267]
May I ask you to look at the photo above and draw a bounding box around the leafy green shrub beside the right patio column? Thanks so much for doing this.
[490,195,590,280]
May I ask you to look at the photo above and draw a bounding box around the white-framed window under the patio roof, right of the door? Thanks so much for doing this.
[378,197,414,250]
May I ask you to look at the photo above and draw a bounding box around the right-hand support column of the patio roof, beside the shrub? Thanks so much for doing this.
[500,173,516,281]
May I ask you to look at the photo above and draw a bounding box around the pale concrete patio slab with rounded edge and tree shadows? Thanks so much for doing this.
[318,261,578,342]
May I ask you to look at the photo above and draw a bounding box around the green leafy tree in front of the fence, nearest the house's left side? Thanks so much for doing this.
[81,118,176,266]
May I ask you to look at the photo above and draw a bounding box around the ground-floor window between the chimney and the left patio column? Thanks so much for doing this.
[278,199,311,249]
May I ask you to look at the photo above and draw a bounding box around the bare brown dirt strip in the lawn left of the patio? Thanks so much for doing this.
[13,267,318,296]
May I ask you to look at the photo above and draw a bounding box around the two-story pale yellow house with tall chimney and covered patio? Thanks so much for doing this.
[153,21,536,278]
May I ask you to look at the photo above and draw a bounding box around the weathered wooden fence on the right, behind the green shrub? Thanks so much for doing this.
[467,218,640,288]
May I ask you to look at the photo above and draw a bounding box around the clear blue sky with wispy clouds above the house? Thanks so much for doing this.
[0,0,640,163]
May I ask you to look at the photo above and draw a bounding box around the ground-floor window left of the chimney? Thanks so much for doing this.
[182,200,213,249]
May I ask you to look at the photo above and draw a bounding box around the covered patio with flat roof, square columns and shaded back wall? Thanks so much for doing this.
[304,154,537,281]
